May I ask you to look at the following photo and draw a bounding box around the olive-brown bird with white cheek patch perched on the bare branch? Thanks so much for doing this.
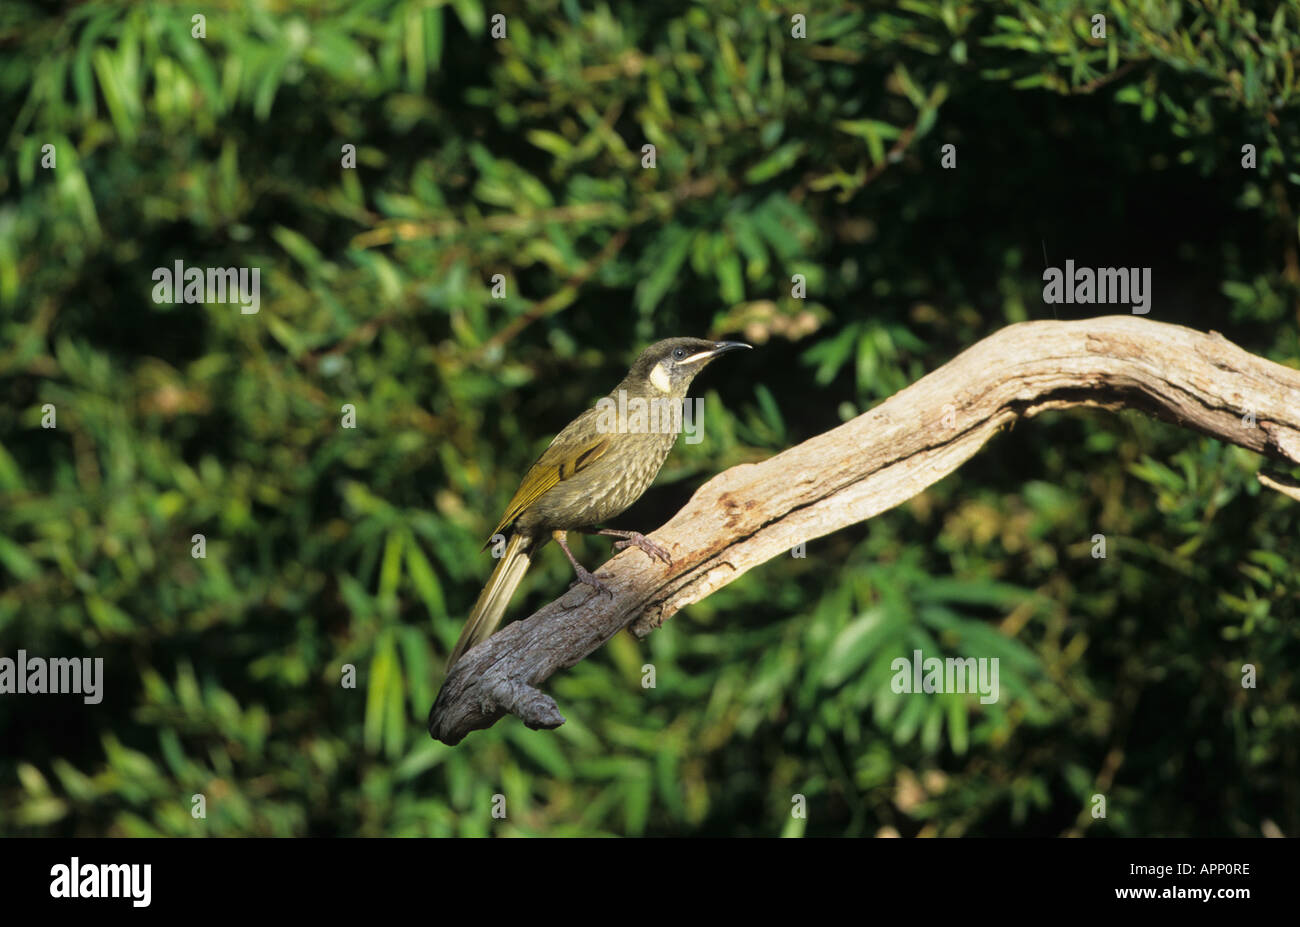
[447,338,751,671]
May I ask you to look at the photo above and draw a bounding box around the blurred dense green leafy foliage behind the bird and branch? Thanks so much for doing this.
[0,0,1300,836]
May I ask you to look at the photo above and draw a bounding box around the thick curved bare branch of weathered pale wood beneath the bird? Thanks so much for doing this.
[429,316,1300,744]
